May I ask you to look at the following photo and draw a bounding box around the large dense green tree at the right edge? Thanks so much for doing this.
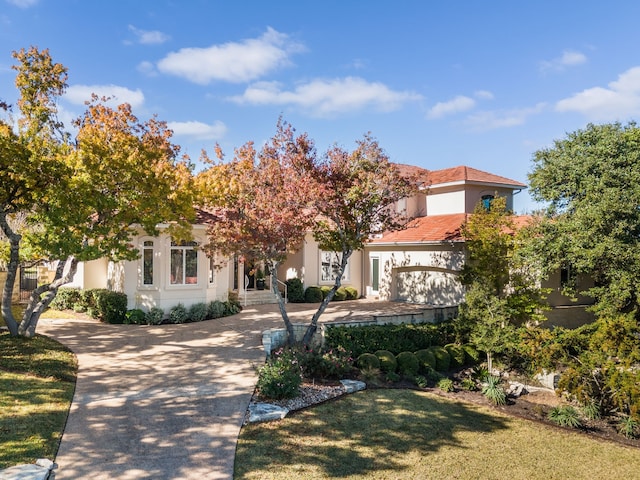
[529,123,640,316]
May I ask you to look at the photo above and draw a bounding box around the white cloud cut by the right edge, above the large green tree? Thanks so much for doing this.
[556,67,640,121]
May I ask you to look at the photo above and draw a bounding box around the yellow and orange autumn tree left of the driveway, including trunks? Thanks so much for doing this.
[0,47,194,336]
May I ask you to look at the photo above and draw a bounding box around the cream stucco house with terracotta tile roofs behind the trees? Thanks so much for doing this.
[62,165,587,324]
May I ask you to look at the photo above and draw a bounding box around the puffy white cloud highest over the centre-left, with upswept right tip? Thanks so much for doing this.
[158,28,303,85]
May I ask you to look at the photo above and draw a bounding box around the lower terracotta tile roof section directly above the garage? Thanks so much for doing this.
[370,213,468,244]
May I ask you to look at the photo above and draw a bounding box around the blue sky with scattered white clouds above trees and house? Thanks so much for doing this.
[0,0,640,213]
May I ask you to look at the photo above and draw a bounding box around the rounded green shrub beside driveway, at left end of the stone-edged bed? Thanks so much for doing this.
[256,356,302,400]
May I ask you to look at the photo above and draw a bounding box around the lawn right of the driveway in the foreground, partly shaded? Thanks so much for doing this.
[234,390,640,480]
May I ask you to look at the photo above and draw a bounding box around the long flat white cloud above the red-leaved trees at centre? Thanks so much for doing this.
[230,77,422,117]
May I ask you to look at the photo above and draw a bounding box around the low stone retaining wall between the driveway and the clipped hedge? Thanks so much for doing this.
[262,306,458,355]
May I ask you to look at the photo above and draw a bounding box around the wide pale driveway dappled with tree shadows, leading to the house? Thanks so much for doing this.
[38,300,424,480]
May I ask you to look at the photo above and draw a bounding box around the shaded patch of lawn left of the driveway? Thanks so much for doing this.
[0,332,77,468]
